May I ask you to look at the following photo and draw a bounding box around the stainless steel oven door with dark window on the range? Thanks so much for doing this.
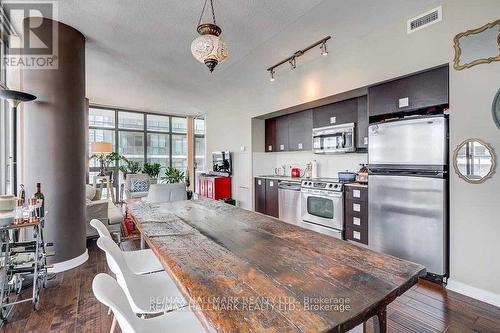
[302,191,344,230]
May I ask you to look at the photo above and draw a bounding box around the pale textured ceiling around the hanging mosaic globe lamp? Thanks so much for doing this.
[47,0,322,114]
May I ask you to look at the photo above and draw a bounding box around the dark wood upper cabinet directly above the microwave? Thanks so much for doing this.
[313,98,358,128]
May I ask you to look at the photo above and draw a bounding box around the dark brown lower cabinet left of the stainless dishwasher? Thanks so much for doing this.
[255,178,279,218]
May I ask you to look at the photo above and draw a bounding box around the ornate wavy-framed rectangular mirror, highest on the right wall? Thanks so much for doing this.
[453,20,500,70]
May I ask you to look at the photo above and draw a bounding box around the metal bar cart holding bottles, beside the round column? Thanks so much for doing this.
[0,209,52,321]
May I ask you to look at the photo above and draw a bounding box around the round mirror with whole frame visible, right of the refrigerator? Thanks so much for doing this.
[453,139,496,184]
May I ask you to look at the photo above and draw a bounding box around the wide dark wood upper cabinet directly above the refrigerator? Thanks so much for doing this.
[368,66,449,117]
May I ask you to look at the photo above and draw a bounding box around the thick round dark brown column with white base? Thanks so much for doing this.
[22,18,88,271]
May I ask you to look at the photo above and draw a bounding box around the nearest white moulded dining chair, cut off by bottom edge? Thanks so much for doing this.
[92,273,205,333]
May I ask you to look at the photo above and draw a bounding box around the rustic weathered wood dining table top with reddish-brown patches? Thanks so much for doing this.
[128,199,425,333]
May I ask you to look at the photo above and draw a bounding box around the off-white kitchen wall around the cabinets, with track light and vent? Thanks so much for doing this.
[207,0,500,299]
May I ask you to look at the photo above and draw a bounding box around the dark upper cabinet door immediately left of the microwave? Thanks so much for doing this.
[288,110,312,150]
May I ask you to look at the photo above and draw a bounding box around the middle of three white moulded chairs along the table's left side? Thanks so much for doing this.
[97,237,187,314]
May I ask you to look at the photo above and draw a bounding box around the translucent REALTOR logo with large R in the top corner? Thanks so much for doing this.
[2,0,58,69]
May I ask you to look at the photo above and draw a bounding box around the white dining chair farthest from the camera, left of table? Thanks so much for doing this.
[90,219,163,274]
